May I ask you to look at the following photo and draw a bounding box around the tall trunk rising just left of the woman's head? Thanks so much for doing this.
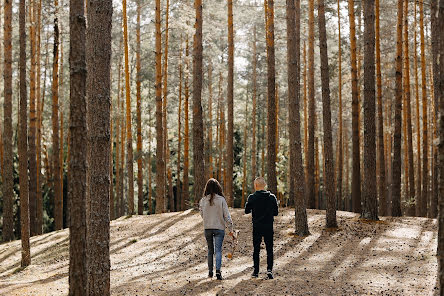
[193,0,205,207]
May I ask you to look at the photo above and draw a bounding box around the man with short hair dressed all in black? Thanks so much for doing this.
[245,177,278,279]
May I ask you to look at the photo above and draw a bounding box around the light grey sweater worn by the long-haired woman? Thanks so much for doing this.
[199,194,233,231]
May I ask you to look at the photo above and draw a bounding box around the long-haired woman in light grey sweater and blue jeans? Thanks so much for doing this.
[199,178,233,280]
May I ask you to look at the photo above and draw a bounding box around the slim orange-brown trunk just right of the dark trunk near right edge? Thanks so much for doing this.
[404,1,415,216]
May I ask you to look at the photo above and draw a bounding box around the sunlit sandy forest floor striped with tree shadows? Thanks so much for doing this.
[0,209,437,296]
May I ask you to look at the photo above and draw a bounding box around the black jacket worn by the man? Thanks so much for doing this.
[245,190,278,227]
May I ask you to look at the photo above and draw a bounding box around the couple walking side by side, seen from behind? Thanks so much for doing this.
[199,177,278,280]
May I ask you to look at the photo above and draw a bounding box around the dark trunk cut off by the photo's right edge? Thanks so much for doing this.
[435,0,444,291]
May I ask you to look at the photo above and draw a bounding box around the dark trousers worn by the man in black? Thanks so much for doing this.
[253,225,273,273]
